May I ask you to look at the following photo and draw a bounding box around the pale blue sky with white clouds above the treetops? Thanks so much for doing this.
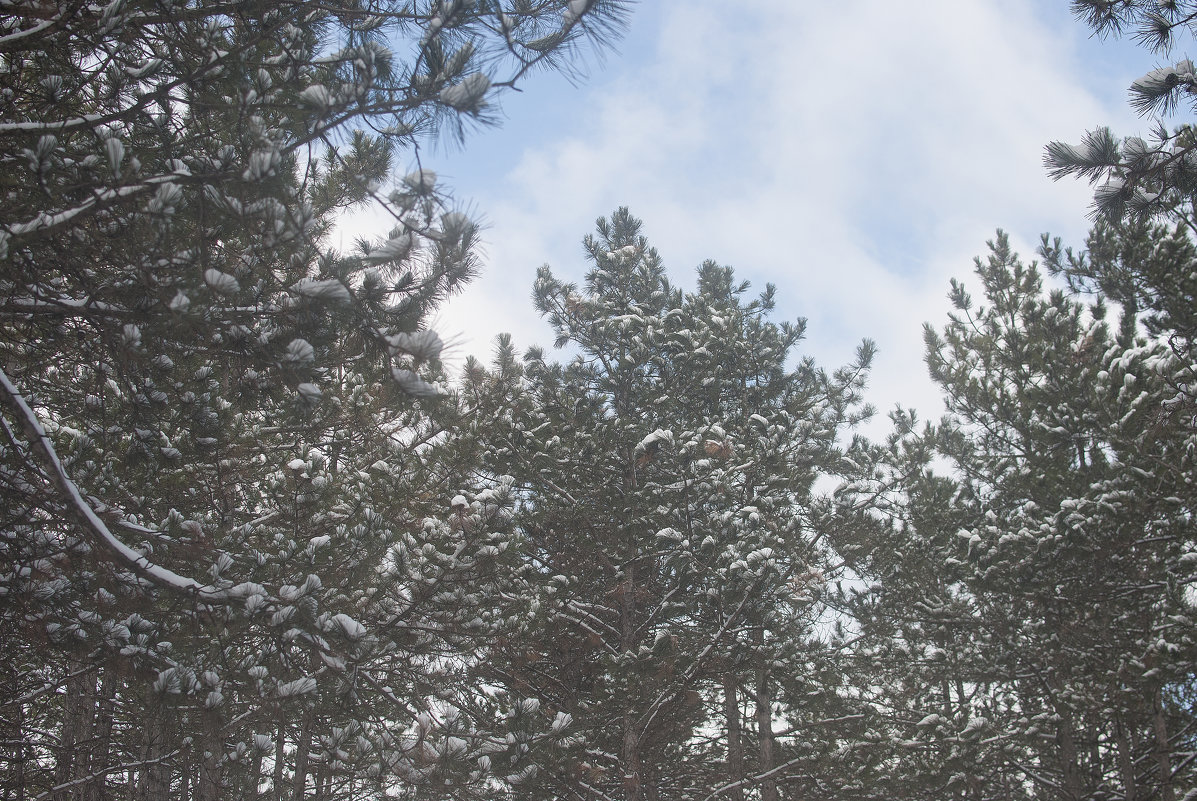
[347,0,1157,433]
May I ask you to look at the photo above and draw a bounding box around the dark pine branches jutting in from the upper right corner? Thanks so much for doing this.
[1044,0,1197,423]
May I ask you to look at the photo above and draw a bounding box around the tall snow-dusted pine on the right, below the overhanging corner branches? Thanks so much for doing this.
[855,235,1197,799]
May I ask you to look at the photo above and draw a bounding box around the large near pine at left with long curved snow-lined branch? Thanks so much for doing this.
[0,0,622,799]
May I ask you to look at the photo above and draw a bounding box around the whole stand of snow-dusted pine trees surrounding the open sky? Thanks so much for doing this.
[0,0,1197,801]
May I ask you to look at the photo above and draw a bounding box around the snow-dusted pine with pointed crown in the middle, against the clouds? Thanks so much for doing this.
[467,210,871,801]
